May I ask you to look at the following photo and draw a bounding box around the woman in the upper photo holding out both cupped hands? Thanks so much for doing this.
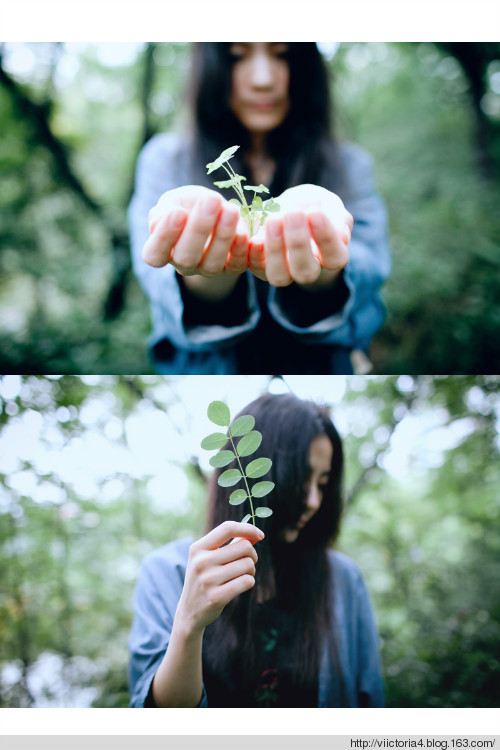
[129,42,390,374]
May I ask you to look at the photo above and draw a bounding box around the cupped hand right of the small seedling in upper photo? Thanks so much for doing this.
[249,185,354,289]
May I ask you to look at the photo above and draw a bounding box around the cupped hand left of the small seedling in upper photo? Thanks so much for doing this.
[142,185,249,277]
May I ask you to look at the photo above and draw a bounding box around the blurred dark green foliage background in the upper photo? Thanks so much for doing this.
[0,43,500,373]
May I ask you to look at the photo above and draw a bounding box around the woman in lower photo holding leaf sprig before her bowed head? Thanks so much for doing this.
[130,394,383,708]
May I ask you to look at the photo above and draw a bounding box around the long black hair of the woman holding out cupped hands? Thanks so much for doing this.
[186,42,341,195]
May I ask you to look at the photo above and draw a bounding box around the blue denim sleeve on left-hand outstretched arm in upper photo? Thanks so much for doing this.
[128,134,260,352]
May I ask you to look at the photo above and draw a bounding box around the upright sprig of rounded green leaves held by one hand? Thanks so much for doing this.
[201,401,274,526]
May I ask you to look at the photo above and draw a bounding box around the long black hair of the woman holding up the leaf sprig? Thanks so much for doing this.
[203,394,343,708]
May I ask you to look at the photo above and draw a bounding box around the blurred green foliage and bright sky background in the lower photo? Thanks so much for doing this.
[0,376,500,707]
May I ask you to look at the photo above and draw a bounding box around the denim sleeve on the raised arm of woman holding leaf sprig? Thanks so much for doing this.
[129,554,207,708]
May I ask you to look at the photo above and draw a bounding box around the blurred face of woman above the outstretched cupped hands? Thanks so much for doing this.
[230,42,290,134]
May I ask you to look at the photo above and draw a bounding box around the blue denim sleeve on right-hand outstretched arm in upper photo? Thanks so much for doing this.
[268,145,391,349]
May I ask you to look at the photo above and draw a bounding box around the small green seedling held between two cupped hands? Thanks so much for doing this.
[207,146,280,237]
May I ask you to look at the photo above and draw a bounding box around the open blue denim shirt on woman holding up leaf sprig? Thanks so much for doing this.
[129,539,384,708]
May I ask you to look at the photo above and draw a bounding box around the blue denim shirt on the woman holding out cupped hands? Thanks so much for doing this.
[128,133,390,375]
